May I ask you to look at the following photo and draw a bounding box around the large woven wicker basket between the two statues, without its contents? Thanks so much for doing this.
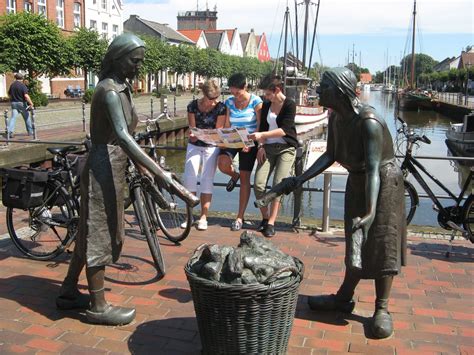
[184,254,304,354]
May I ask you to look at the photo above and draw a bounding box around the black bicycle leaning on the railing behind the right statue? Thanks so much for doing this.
[397,117,474,256]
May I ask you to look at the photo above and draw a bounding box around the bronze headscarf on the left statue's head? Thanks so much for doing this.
[99,33,145,80]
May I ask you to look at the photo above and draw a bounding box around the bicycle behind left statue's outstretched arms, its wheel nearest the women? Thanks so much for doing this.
[129,112,193,244]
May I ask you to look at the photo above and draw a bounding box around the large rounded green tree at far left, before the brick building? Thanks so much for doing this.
[0,12,72,90]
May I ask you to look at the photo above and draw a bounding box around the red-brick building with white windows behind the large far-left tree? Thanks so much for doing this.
[0,0,85,97]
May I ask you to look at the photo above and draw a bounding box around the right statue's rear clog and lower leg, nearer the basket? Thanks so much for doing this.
[308,270,360,313]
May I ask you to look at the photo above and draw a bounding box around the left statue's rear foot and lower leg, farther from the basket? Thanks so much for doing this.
[56,252,91,310]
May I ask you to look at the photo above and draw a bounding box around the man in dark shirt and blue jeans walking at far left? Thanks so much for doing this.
[7,73,34,138]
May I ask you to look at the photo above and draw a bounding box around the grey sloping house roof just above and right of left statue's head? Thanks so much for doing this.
[123,15,194,45]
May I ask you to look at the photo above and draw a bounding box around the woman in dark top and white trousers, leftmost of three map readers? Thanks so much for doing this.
[182,80,227,230]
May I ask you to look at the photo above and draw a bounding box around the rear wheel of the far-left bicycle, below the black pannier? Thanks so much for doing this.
[7,181,78,260]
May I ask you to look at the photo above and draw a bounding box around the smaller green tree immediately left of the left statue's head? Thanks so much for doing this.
[67,27,108,90]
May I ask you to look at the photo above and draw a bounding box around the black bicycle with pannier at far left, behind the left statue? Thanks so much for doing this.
[2,146,80,260]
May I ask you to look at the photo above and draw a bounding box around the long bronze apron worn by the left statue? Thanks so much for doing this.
[76,82,138,267]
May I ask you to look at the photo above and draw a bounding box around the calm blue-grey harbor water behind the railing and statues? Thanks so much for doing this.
[163,91,469,226]
